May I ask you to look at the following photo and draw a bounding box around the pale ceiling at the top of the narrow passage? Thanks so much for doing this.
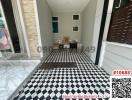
[47,0,90,12]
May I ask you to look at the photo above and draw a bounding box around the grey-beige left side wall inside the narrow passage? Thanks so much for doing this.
[37,0,53,56]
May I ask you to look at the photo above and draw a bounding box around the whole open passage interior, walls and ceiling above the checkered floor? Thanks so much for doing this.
[36,0,104,62]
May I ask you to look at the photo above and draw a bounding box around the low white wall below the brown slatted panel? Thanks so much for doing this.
[102,42,132,74]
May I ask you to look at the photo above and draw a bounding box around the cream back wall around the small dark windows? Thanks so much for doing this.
[53,12,81,41]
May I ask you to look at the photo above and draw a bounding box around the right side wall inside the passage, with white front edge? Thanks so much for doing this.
[82,0,104,62]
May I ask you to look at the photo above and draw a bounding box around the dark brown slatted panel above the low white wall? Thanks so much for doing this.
[107,3,132,44]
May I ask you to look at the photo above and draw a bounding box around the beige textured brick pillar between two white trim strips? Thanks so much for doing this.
[21,0,40,56]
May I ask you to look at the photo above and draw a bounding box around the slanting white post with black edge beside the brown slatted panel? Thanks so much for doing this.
[96,0,114,67]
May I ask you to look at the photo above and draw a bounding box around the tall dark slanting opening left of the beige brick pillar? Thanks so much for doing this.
[1,0,21,53]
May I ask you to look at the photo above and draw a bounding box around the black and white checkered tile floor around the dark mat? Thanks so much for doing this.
[14,51,110,100]
